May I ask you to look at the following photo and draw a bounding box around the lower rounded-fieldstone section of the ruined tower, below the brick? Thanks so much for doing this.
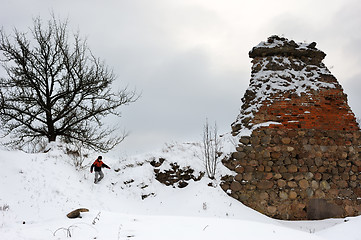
[221,128,361,220]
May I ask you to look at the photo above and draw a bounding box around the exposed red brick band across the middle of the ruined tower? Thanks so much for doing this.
[253,89,359,131]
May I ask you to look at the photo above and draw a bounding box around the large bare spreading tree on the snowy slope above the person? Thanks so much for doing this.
[0,16,138,152]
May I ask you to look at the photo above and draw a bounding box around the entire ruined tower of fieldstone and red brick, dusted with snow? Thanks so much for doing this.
[221,36,361,220]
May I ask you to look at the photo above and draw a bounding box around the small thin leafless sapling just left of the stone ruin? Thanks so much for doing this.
[202,119,220,179]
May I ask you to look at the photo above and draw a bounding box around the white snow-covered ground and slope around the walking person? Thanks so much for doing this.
[0,144,361,240]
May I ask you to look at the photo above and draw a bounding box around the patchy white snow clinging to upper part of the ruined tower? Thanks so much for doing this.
[235,53,338,135]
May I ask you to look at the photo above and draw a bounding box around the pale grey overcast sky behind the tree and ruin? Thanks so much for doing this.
[0,0,361,155]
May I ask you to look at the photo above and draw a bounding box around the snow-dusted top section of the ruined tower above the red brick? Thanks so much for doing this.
[232,36,341,134]
